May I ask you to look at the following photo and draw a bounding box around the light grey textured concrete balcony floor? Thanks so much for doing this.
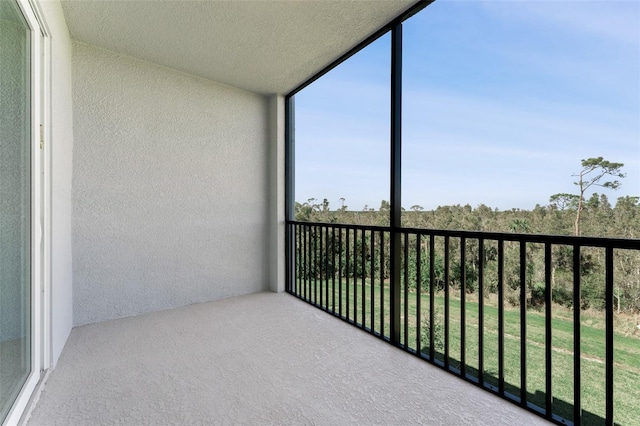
[23,293,547,426]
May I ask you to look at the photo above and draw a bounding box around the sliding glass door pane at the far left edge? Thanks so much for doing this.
[0,0,33,422]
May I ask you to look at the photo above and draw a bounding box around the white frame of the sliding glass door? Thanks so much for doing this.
[4,0,51,424]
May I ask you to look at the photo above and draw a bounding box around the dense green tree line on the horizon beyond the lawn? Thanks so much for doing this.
[295,157,640,315]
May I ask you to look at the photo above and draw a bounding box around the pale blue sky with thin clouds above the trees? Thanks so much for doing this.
[295,0,640,210]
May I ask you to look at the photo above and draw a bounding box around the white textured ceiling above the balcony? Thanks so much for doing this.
[62,0,417,94]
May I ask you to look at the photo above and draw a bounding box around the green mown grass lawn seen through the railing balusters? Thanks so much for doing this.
[294,279,640,425]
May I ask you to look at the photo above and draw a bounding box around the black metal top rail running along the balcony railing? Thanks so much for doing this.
[287,220,640,250]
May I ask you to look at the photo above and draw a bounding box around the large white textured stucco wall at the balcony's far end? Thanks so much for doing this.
[73,42,269,325]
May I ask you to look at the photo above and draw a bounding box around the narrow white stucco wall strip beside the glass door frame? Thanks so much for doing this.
[40,0,73,365]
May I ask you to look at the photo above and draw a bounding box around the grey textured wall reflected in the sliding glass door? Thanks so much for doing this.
[0,6,31,341]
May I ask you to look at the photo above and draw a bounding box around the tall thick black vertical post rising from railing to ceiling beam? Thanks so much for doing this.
[389,23,402,345]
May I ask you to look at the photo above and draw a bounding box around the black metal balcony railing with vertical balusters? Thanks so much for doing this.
[287,221,640,424]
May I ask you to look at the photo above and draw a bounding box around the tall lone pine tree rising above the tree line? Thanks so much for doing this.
[572,157,626,235]
